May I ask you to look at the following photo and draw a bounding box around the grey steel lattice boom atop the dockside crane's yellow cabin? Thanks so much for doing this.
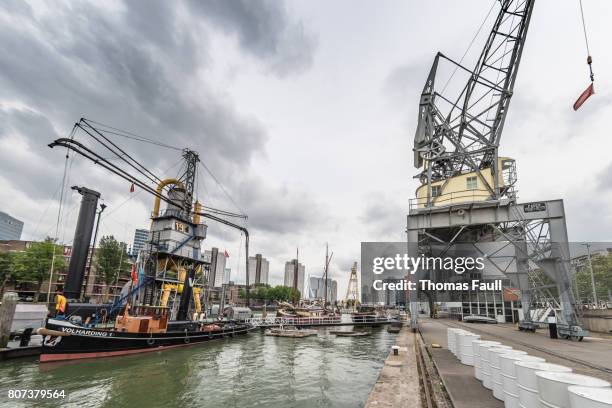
[414,0,535,204]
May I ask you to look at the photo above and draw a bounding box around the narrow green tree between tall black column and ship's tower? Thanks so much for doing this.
[94,235,131,302]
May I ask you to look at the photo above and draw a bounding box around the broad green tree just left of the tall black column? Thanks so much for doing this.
[13,238,66,302]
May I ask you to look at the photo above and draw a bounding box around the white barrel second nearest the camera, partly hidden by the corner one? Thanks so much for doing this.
[535,371,610,408]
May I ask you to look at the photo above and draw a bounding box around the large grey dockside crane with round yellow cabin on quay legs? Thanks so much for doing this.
[406,0,586,339]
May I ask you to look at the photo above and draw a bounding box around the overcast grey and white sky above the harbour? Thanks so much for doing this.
[0,0,612,296]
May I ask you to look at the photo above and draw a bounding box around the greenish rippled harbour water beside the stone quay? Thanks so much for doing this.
[0,327,395,408]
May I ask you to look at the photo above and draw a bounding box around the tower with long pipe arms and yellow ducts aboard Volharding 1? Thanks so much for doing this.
[49,118,250,320]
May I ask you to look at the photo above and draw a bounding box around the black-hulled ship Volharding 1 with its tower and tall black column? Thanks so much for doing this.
[38,123,251,362]
